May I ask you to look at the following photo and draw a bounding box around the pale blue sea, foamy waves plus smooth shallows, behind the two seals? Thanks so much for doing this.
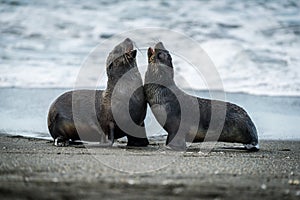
[0,0,300,139]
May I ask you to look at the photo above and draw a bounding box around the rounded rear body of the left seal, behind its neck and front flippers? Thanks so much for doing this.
[47,90,103,146]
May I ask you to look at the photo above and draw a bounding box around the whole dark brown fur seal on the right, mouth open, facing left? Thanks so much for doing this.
[144,42,259,151]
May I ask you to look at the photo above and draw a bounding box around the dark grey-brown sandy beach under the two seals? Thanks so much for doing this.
[0,135,300,199]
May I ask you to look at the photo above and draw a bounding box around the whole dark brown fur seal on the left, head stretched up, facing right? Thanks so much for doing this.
[48,38,149,146]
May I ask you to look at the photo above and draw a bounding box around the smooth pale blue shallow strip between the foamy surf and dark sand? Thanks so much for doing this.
[0,88,300,140]
